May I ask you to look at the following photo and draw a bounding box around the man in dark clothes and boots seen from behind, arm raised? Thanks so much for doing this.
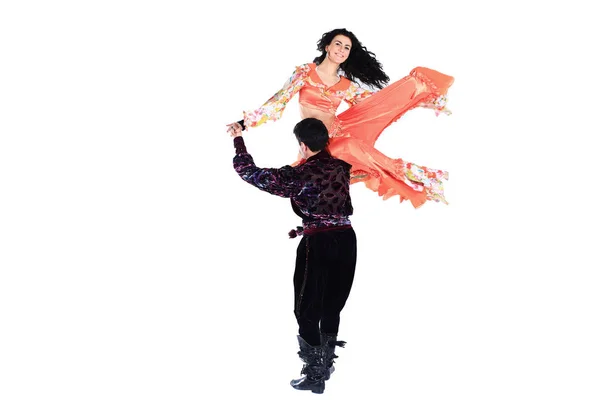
[228,118,356,393]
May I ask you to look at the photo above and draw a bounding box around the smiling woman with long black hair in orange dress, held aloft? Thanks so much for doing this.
[227,28,454,208]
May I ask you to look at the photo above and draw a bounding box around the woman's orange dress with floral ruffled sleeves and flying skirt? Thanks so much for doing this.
[244,63,454,208]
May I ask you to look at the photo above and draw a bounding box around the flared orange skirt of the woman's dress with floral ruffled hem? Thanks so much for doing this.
[328,67,454,208]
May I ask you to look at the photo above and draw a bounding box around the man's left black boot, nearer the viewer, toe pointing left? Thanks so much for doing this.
[290,335,325,393]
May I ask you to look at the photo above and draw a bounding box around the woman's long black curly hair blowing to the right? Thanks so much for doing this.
[313,28,390,89]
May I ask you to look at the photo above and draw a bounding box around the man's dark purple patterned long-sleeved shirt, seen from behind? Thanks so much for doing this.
[233,136,353,233]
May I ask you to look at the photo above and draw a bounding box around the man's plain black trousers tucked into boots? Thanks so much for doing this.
[294,228,356,346]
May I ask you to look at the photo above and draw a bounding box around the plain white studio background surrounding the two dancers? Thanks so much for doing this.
[0,0,600,400]
